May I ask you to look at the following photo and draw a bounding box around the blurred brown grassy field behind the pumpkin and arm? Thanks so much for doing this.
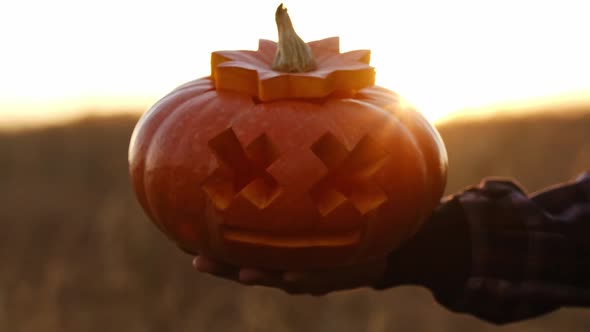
[0,109,590,332]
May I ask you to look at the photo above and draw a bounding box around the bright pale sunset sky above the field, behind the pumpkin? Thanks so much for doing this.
[0,0,590,127]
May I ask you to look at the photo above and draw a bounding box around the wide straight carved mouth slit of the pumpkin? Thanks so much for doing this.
[221,225,363,248]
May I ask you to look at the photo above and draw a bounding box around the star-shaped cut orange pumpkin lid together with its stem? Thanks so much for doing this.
[211,4,375,102]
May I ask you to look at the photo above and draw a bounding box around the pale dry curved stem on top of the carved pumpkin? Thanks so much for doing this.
[272,3,316,73]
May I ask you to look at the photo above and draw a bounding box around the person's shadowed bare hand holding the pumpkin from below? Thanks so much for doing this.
[193,255,387,296]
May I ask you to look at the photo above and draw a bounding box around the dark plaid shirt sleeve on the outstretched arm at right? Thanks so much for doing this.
[377,172,590,324]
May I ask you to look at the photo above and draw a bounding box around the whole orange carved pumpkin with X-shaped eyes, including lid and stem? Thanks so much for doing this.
[129,5,447,270]
